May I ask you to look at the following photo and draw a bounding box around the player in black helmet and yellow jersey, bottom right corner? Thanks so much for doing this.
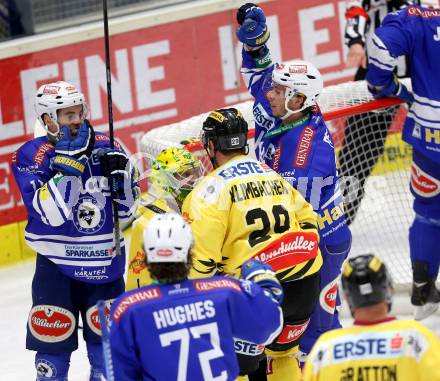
[303,254,440,381]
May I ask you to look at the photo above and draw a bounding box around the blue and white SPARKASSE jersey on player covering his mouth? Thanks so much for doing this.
[12,133,136,283]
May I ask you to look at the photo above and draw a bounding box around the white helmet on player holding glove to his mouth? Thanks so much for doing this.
[35,81,87,136]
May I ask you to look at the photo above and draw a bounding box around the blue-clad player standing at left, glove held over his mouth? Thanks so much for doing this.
[12,81,138,381]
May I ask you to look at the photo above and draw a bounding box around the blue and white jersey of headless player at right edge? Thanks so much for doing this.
[366,7,440,163]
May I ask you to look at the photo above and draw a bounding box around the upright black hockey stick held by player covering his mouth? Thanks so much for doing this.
[102,0,121,255]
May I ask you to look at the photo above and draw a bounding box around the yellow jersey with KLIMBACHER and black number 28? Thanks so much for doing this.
[182,155,322,281]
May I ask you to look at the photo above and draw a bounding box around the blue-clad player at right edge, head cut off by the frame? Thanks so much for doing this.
[367,7,440,320]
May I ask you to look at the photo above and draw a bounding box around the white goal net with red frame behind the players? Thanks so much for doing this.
[141,81,413,288]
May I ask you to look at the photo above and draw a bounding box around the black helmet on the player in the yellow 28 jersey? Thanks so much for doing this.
[201,108,248,151]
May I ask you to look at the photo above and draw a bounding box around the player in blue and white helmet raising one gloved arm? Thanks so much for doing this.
[237,3,351,366]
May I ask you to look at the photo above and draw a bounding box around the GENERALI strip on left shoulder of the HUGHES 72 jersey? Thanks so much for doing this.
[110,285,162,322]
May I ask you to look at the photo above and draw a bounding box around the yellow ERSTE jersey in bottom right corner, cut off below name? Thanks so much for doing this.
[303,319,440,381]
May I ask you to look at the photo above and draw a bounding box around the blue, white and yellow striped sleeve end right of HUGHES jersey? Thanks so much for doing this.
[241,258,283,303]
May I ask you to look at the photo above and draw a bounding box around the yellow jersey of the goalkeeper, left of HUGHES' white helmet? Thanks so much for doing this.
[125,200,170,291]
